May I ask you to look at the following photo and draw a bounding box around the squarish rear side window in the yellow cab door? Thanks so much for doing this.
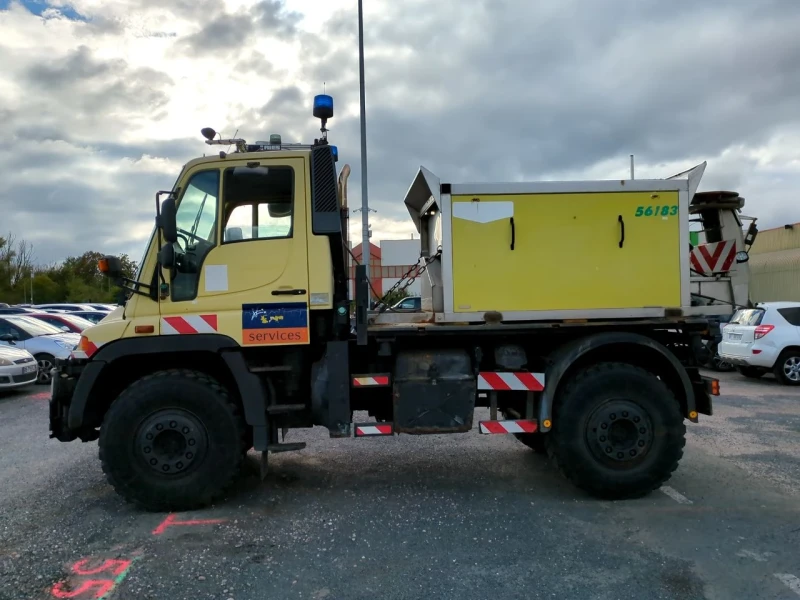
[222,166,294,244]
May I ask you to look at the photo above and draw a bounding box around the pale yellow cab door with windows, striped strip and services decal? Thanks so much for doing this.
[161,157,309,346]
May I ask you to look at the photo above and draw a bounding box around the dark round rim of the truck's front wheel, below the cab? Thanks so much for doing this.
[134,408,208,476]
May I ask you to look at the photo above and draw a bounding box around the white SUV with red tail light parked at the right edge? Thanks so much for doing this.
[719,302,800,385]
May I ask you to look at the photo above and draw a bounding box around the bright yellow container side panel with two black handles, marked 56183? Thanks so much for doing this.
[452,192,681,312]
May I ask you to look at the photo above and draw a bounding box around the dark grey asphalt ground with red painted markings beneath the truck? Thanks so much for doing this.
[0,373,800,600]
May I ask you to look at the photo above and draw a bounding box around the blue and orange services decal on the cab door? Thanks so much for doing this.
[242,302,308,346]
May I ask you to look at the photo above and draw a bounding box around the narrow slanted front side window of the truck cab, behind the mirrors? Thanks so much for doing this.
[171,171,219,301]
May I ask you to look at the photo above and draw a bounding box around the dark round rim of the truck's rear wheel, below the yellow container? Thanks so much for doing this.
[586,399,654,467]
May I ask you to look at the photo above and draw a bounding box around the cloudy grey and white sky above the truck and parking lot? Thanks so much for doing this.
[0,0,800,263]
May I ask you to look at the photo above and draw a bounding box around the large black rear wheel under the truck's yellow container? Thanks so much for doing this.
[544,363,686,500]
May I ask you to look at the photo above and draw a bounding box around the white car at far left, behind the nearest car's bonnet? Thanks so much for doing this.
[0,315,81,383]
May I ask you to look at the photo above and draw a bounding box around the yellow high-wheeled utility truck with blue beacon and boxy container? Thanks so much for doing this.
[50,96,747,510]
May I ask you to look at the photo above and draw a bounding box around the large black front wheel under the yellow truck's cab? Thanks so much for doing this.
[99,369,246,511]
